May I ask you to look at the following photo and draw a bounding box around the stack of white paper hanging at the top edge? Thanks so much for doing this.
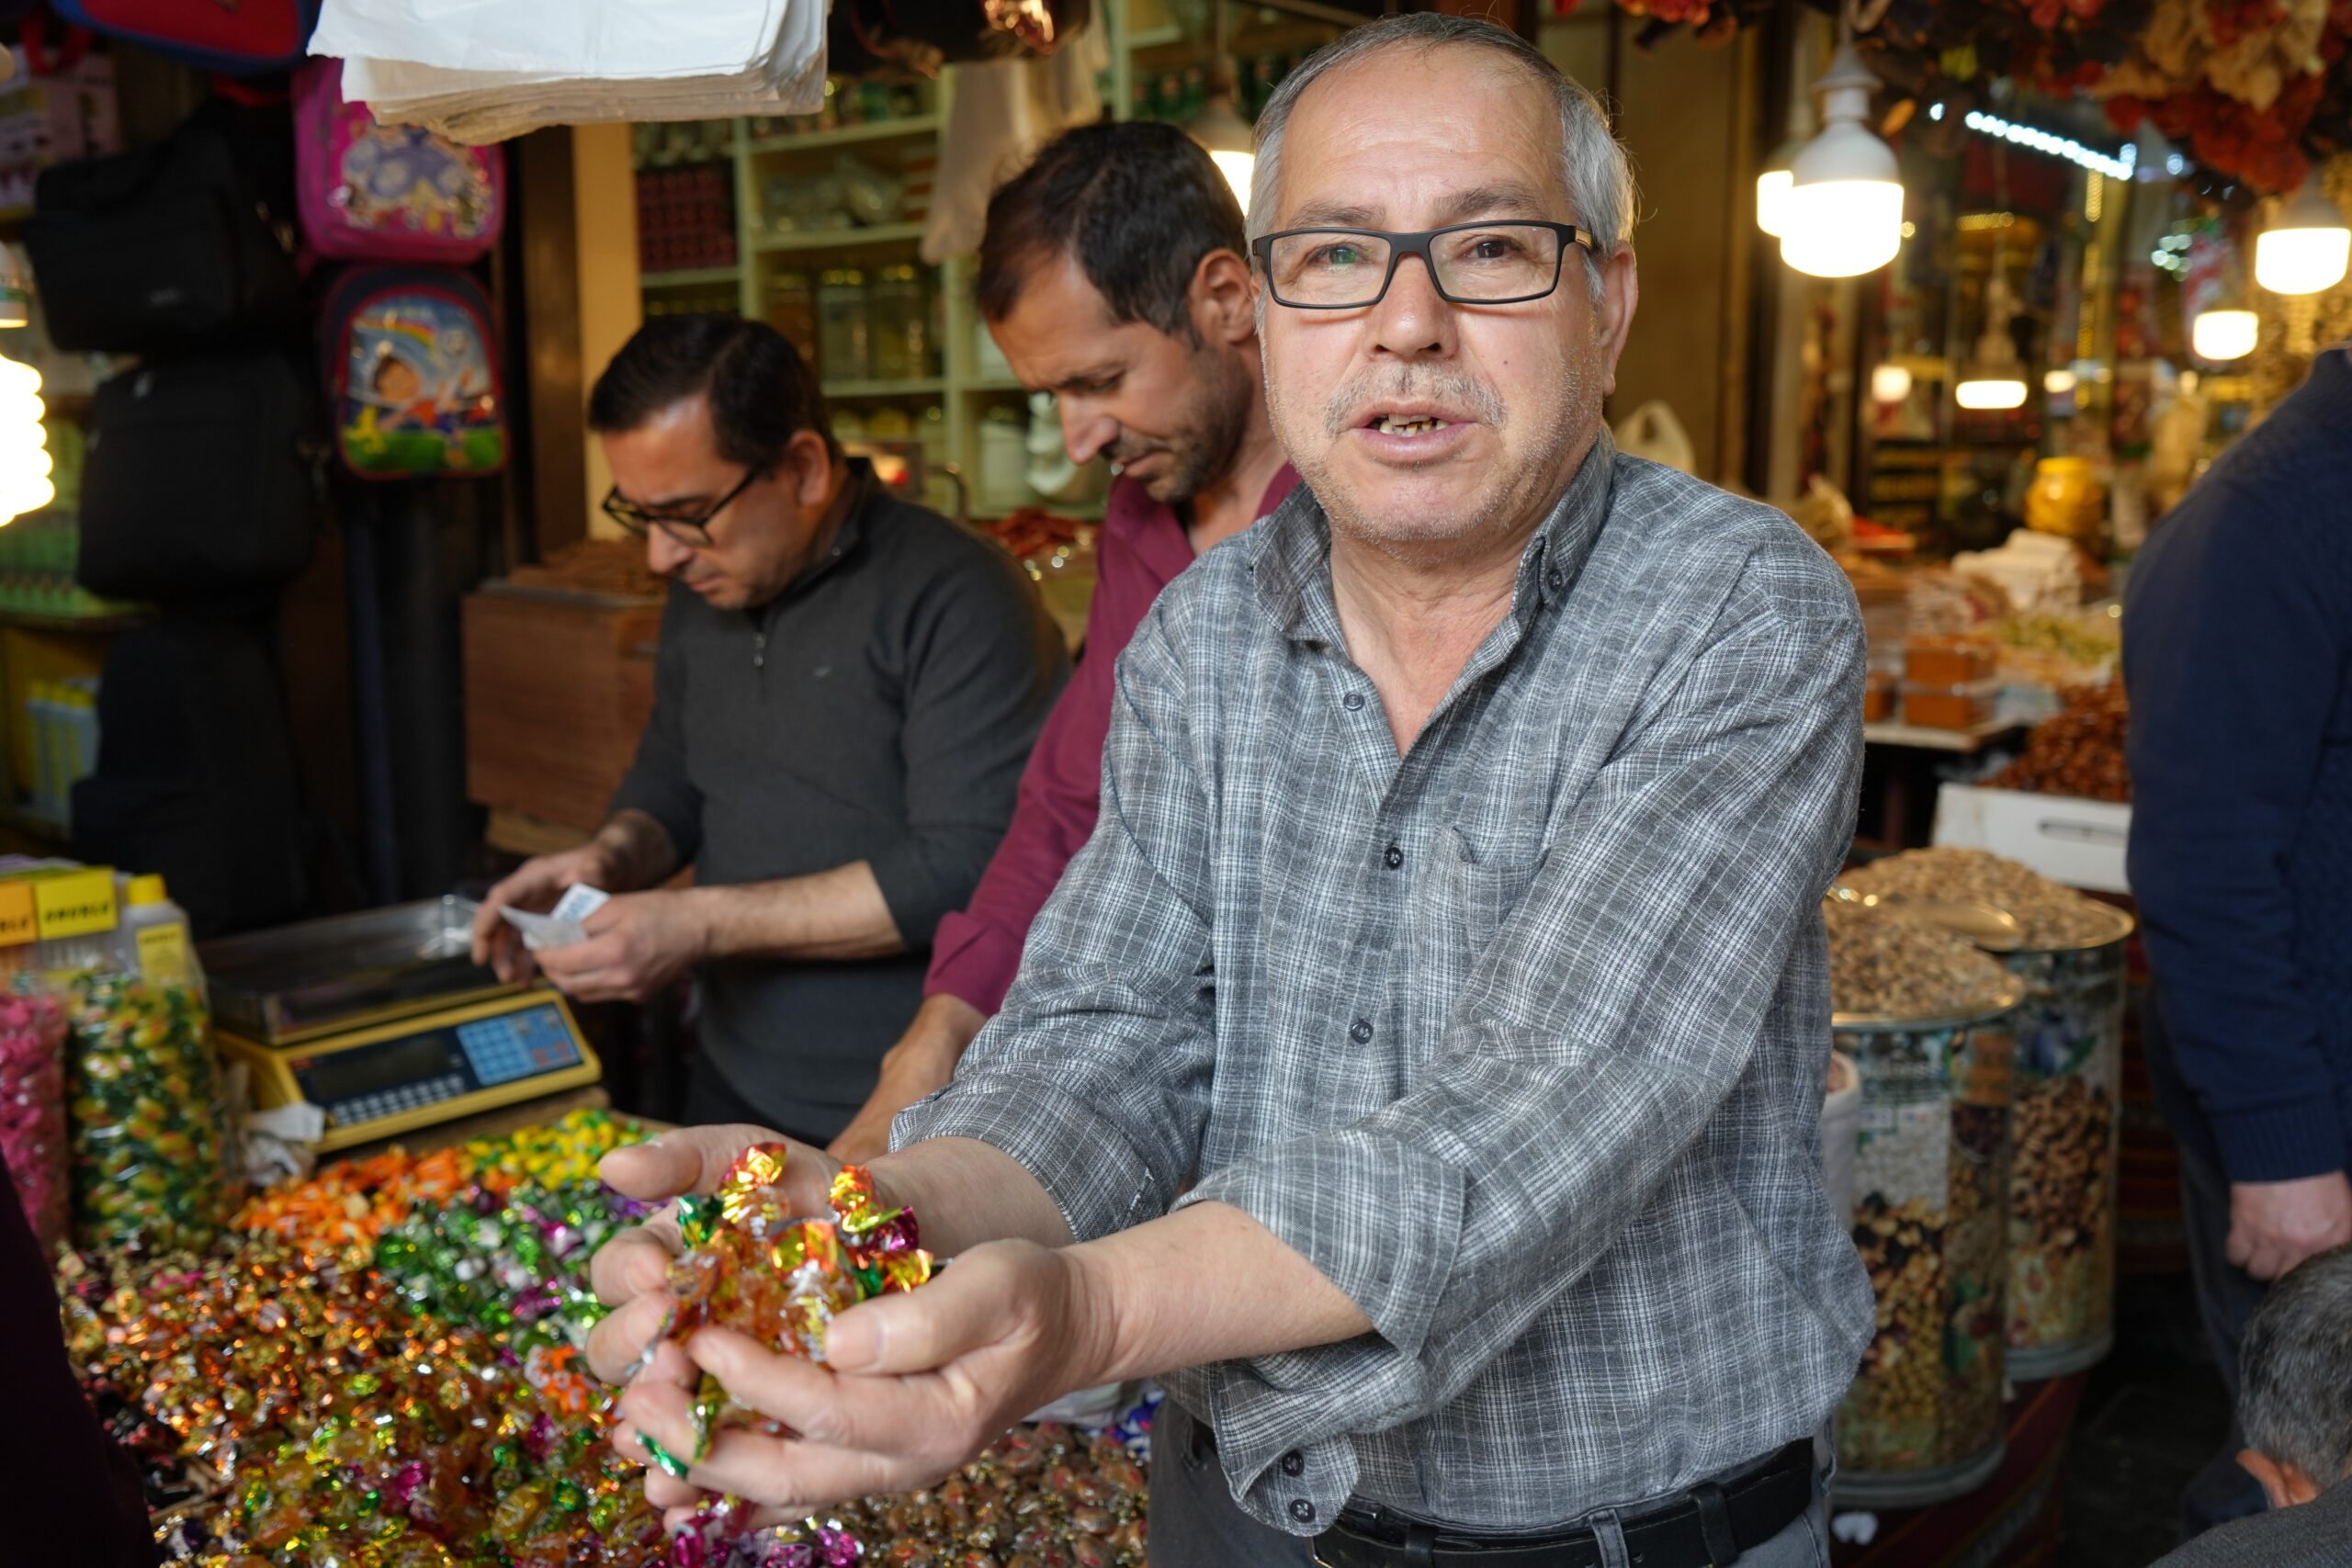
[311,0,826,146]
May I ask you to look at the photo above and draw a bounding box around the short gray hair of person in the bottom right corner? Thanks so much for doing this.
[2237,1246,2352,1491]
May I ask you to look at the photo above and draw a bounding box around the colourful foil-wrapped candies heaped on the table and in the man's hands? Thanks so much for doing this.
[62,1112,1143,1568]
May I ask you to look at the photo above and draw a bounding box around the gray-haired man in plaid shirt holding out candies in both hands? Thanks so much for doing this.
[591,14,1872,1568]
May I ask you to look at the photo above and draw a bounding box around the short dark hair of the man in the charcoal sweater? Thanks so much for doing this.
[588,315,840,468]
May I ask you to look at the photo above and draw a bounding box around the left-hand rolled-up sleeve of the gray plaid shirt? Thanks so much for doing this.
[891,587,1216,1241]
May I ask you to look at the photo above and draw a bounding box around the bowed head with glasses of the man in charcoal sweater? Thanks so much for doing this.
[588,315,842,609]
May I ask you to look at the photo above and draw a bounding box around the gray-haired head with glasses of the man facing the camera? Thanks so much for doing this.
[1249,4,1637,559]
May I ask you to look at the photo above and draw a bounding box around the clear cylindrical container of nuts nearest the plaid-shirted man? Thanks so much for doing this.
[1832,987,2020,1506]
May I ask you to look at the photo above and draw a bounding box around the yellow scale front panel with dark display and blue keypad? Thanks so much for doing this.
[258,995,597,1147]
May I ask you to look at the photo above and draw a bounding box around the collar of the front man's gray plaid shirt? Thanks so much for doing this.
[1249,425,1616,642]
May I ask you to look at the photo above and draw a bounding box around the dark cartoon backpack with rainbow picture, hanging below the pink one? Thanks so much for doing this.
[320,268,508,479]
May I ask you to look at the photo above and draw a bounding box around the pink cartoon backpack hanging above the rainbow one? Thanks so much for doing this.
[294,59,505,265]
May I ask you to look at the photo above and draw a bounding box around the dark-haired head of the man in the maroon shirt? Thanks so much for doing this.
[974,120,1259,505]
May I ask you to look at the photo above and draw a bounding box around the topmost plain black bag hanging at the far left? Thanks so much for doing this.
[24,101,297,353]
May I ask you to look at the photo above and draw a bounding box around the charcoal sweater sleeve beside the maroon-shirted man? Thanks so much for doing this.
[870,547,1070,947]
